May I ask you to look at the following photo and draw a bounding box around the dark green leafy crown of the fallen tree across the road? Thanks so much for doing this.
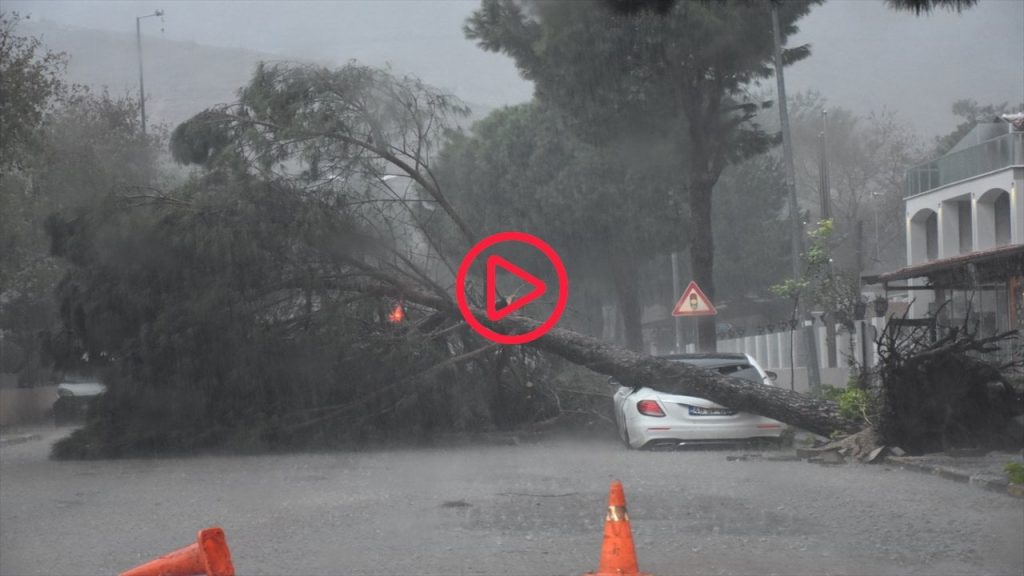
[48,61,565,458]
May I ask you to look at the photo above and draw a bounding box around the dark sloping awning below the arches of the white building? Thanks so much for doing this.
[861,244,1024,288]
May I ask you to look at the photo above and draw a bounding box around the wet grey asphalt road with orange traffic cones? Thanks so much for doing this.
[0,431,1024,576]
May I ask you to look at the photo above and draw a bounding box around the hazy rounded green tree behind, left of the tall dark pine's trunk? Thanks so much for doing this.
[435,102,685,348]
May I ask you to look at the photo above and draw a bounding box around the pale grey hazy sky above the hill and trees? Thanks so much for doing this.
[9,0,1024,135]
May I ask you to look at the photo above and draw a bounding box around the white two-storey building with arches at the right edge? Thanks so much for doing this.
[864,115,1024,334]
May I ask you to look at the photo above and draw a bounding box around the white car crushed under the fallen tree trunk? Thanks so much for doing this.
[613,353,785,448]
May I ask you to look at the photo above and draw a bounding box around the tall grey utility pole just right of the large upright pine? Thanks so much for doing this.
[771,0,821,392]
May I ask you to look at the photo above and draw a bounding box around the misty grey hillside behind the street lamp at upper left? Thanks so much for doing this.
[19,20,492,127]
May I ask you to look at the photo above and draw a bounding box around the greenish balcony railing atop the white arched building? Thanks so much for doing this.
[904,132,1024,197]
